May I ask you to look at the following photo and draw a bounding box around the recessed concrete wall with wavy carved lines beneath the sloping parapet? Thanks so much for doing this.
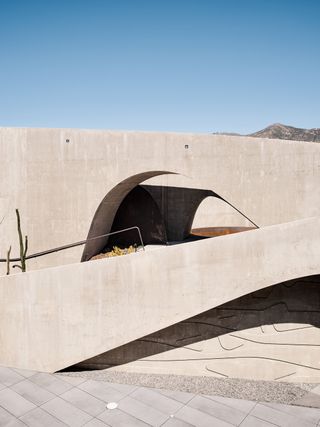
[74,276,320,383]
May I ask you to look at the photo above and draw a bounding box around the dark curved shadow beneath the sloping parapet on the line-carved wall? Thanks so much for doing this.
[65,276,320,371]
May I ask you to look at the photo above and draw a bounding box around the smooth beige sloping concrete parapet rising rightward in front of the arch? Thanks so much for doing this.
[0,218,320,372]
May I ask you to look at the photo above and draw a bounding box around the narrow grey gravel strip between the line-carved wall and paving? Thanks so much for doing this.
[58,370,318,404]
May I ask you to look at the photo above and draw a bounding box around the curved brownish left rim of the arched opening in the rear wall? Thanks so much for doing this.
[81,171,176,262]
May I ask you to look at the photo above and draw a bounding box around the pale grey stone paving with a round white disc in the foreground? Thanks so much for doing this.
[0,367,320,427]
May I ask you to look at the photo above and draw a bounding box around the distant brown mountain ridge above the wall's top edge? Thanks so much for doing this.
[216,123,320,142]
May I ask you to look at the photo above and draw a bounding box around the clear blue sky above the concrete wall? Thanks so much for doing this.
[0,0,320,133]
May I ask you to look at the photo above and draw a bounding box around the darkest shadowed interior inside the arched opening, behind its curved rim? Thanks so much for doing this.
[86,185,225,255]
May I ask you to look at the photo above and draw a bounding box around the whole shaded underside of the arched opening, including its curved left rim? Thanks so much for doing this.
[81,171,258,261]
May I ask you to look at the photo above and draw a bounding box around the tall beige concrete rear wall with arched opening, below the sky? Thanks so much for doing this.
[0,128,320,273]
